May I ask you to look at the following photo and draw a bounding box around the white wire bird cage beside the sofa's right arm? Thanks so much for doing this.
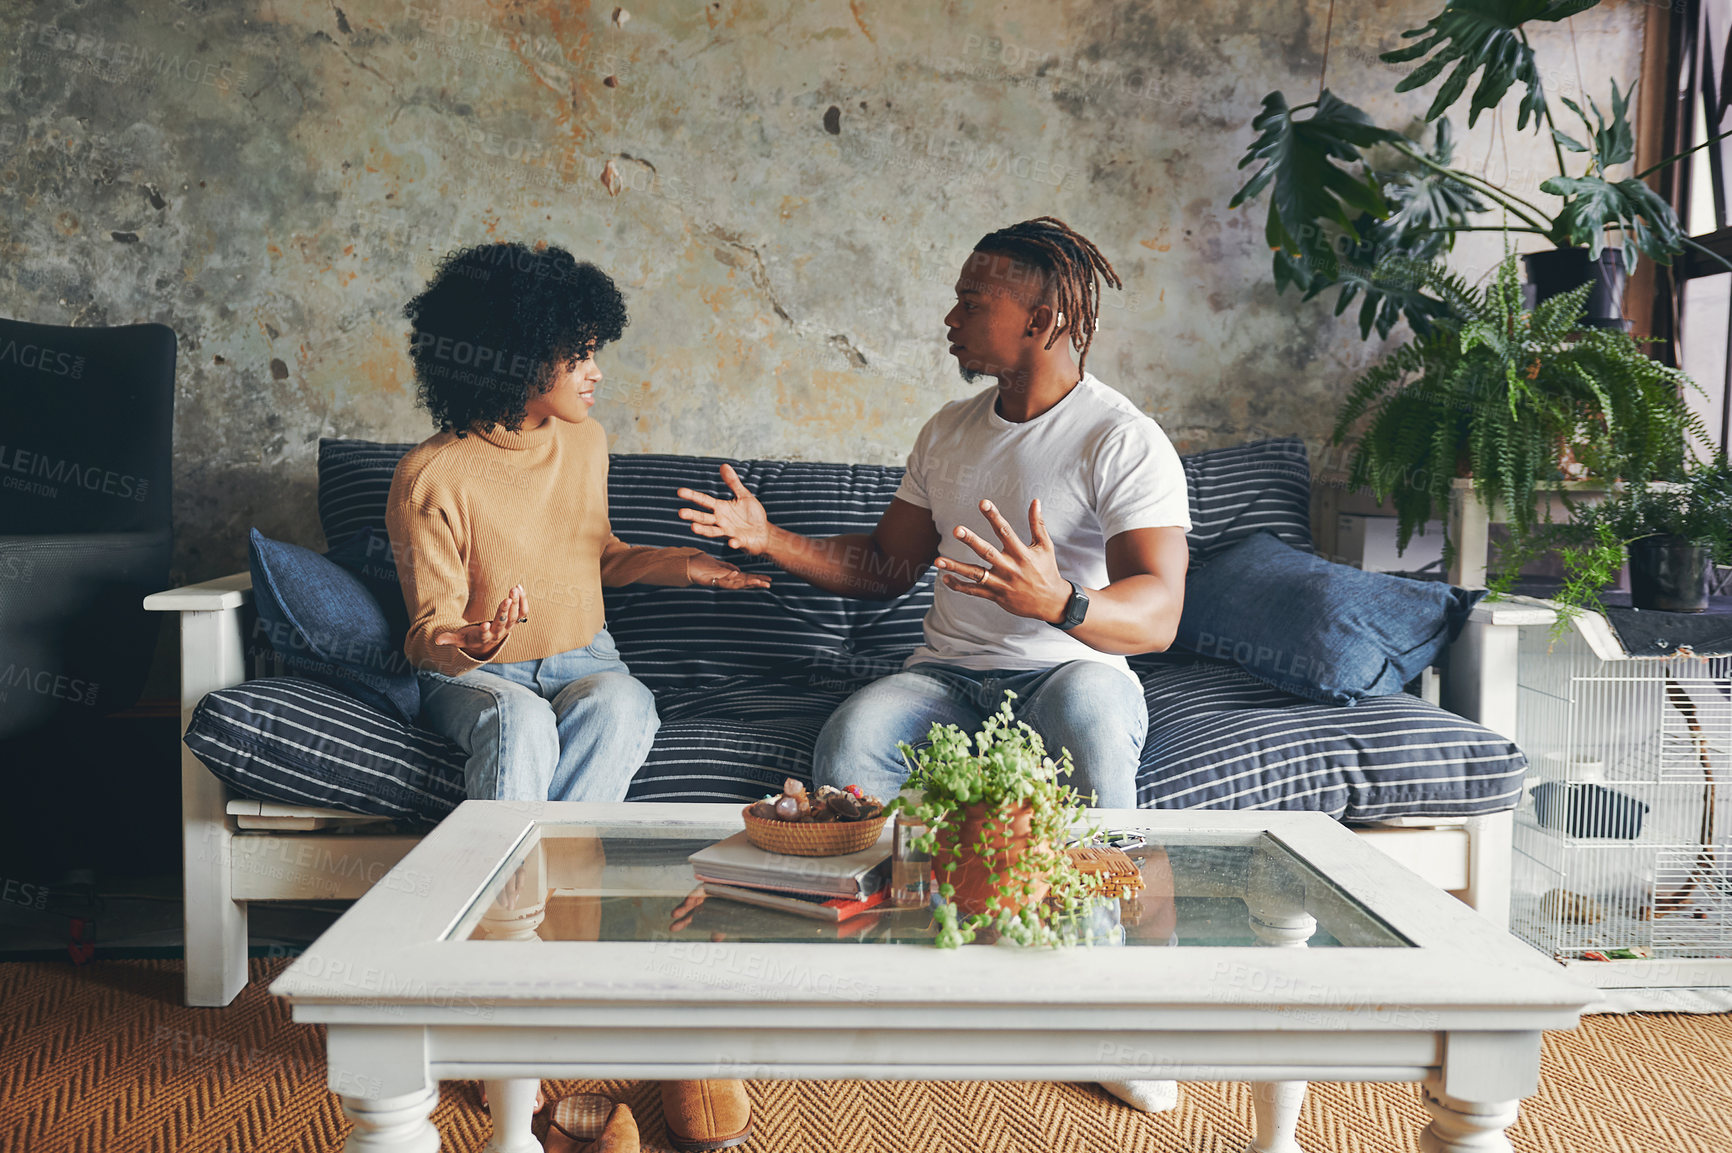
[1510,613,1732,987]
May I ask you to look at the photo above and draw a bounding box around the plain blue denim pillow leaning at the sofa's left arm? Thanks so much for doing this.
[248,528,421,722]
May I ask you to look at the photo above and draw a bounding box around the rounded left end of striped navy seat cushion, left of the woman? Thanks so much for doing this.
[185,677,464,824]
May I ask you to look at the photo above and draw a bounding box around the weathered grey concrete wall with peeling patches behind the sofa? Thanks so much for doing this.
[0,0,1642,578]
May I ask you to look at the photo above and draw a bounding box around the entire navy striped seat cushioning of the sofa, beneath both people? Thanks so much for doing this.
[187,660,1526,822]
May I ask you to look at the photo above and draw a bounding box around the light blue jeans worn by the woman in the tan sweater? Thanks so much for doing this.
[419,628,662,802]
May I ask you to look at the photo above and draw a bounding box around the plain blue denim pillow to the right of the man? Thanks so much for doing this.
[1173,531,1486,705]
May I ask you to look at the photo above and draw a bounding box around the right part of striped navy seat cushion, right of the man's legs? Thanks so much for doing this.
[1136,660,1528,821]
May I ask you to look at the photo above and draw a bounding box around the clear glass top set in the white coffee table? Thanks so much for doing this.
[447,822,1412,949]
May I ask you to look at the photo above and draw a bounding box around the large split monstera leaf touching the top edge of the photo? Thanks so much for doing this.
[1379,0,1599,128]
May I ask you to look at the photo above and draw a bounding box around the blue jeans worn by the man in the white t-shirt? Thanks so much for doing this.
[812,660,1148,808]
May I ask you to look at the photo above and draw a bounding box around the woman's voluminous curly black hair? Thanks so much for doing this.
[404,241,627,436]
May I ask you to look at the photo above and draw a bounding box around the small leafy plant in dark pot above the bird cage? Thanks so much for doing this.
[1491,452,1732,630]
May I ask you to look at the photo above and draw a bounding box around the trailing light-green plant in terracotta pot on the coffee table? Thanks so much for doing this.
[887,692,1089,949]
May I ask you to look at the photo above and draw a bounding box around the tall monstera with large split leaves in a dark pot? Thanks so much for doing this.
[1228,0,1732,338]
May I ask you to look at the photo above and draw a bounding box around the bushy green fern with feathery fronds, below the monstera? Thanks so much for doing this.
[1330,253,1708,563]
